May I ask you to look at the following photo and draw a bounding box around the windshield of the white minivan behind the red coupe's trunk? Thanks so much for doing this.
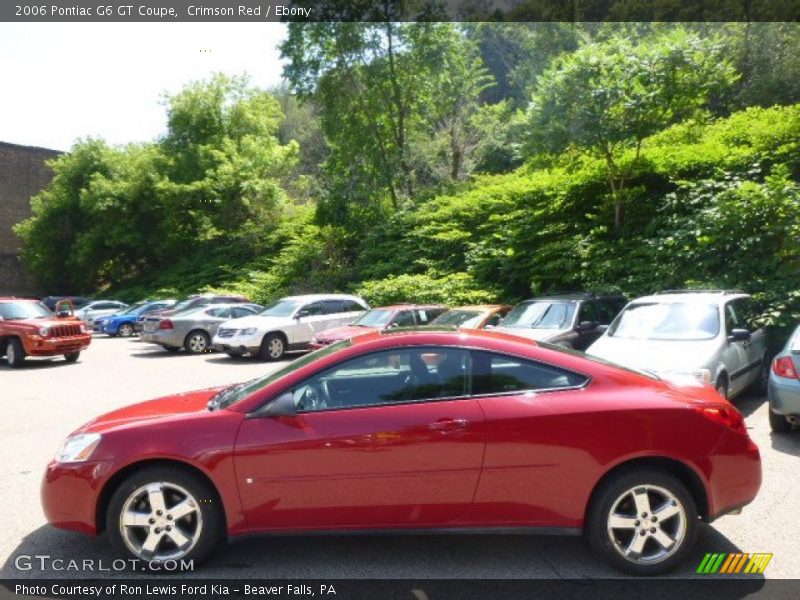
[608,302,719,340]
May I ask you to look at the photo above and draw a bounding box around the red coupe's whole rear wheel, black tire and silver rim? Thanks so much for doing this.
[586,468,699,575]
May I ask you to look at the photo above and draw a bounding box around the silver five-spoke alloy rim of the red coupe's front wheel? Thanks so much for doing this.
[119,481,203,561]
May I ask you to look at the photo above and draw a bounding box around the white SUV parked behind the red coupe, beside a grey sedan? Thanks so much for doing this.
[212,294,369,360]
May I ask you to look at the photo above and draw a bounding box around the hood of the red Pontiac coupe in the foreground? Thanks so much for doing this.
[76,386,227,433]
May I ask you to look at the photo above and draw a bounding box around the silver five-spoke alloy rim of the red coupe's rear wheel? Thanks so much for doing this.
[607,485,686,565]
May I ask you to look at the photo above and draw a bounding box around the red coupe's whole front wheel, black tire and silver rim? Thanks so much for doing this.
[105,467,225,570]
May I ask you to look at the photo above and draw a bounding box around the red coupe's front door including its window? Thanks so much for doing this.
[235,347,485,530]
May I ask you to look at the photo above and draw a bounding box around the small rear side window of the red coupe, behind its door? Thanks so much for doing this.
[472,351,586,394]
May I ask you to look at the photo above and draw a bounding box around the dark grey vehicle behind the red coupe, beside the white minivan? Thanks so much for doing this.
[495,292,626,350]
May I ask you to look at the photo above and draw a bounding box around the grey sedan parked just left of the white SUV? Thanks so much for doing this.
[139,304,263,354]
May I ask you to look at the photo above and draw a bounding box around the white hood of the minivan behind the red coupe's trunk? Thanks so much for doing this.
[586,335,719,373]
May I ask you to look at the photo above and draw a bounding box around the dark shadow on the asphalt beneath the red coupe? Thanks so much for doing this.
[0,525,764,597]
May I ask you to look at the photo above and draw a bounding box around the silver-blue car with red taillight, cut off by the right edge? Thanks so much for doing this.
[768,326,800,433]
